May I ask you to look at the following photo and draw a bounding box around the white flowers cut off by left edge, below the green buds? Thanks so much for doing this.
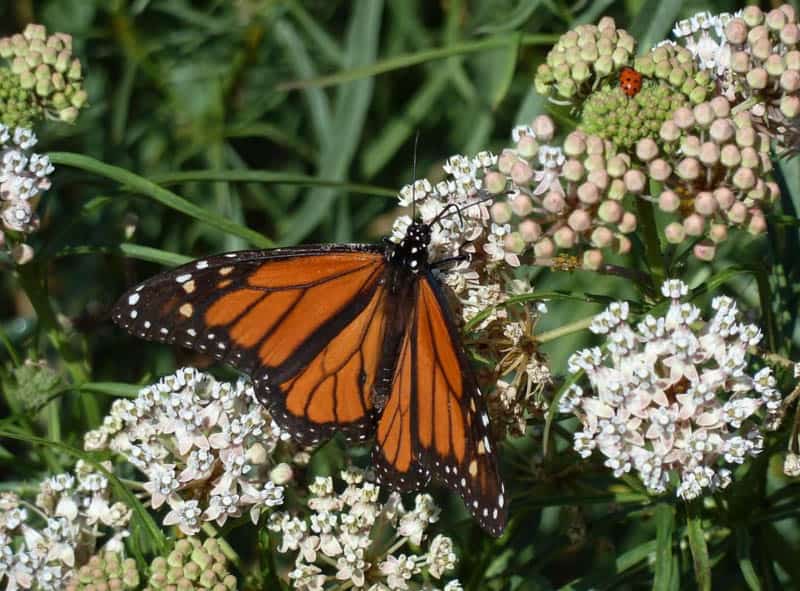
[0,125,54,263]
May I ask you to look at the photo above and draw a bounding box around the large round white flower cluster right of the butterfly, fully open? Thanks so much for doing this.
[559,280,783,499]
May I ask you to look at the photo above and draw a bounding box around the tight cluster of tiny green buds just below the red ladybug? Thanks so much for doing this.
[580,80,688,149]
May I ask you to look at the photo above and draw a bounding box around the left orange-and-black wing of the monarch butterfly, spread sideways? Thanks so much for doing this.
[112,246,387,443]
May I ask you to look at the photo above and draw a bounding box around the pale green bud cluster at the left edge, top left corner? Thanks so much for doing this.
[0,24,87,126]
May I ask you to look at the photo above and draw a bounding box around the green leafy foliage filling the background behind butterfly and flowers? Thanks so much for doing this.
[0,0,800,591]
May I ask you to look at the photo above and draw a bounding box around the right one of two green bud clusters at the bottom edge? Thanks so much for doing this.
[145,536,238,591]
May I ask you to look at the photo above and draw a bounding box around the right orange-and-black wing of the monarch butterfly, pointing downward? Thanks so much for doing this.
[373,276,507,535]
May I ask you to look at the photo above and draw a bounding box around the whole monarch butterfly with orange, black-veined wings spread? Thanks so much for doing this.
[112,205,507,536]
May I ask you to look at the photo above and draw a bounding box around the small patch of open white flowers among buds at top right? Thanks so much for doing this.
[672,10,742,80]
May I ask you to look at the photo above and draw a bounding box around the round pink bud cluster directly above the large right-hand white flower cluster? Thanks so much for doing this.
[635,96,779,260]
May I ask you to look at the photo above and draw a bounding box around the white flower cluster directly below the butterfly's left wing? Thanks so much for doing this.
[84,368,303,535]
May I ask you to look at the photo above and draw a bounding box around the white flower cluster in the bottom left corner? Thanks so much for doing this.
[0,461,131,591]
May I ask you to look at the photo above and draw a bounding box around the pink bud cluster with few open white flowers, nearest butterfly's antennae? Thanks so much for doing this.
[485,117,646,269]
